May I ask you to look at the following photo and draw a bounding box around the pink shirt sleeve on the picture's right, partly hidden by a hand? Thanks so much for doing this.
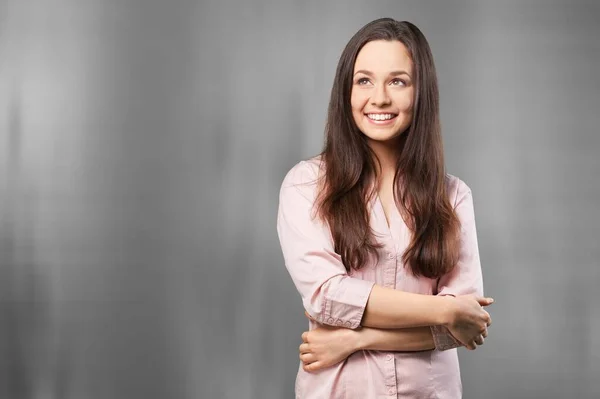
[431,180,483,351]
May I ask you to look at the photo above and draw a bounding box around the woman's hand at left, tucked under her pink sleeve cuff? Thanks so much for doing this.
[299,312,358,372]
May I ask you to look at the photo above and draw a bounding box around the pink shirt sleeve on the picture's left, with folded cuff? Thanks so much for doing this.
[277,161,375,329]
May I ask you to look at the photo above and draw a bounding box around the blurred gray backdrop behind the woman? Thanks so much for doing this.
[0,0,600,399]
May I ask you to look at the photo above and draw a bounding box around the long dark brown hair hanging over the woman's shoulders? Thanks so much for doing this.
[316,18,460,278]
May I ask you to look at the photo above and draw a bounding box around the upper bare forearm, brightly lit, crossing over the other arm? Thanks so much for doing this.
[360,285,450,329]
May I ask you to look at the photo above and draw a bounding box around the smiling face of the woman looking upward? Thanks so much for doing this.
[350,40,414,142]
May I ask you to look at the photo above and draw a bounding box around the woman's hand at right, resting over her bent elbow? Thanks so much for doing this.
[446,295,494,350]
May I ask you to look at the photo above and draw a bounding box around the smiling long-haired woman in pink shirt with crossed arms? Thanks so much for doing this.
[277,18,493,399]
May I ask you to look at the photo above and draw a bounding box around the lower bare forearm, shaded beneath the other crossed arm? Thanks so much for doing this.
[354,327,435,352]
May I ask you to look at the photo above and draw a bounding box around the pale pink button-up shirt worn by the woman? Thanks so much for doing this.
[277,157,483,399]
